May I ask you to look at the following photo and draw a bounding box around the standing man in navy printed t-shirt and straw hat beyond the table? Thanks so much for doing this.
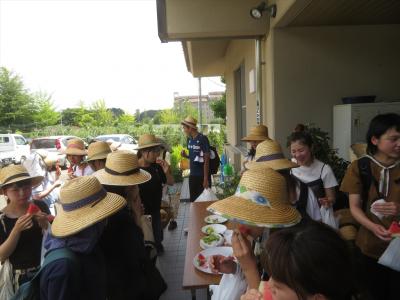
[181,116,211,202]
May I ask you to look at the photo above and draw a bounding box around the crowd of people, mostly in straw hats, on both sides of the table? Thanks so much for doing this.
[0,114,400,300]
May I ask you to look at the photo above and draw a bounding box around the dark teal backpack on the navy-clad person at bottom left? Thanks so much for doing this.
[11,248,79,300]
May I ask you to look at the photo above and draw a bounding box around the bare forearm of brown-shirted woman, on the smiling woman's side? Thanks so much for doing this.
[349,194,392,241]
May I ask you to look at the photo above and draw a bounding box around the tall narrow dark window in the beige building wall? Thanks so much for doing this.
[234,63,247,148]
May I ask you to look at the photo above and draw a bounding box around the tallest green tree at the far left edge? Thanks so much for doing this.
[0,67,35,130]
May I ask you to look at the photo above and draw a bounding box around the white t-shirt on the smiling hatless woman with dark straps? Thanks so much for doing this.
[292,159,338,221]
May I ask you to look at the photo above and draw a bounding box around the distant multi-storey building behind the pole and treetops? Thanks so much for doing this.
[174,92,224,124]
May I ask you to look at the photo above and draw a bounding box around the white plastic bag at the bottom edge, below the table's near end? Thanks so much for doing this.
[211,271,247,300]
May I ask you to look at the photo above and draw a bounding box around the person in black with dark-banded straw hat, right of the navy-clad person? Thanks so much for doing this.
[94,151,167,300]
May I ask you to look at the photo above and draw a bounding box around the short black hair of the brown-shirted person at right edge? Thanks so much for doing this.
[366,113,400,155]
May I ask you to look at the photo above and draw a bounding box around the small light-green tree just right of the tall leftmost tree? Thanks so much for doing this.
[33,92,61,127]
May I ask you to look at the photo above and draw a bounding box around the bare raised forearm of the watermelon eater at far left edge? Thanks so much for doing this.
[0,214,33,261]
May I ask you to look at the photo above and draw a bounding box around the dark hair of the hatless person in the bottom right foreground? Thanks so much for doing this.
[264,221,354,300]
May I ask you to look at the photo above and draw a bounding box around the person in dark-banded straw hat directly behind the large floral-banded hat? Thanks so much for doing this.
[246,139,321,221]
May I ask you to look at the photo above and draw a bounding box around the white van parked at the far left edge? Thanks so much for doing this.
[0,134,30,166]
